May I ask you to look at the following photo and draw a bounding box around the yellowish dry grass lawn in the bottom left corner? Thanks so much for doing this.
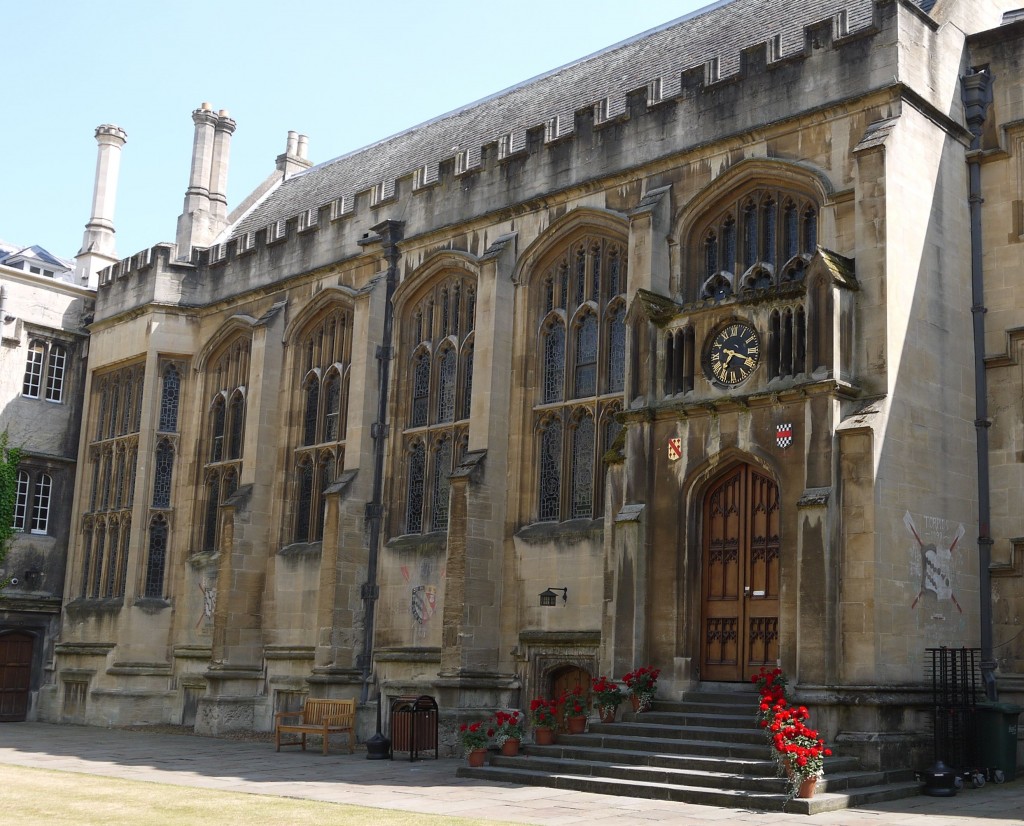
[0,766,512,826]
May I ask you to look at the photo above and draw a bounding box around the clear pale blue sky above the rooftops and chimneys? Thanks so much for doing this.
[0,0,710,258]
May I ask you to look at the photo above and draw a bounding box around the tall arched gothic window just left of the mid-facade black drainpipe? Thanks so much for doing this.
[290,302,352,542]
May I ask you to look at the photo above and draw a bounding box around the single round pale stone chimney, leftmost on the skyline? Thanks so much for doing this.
[75,124,128,289]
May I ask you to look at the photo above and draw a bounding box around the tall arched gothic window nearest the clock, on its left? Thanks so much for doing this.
[530,232,626,522]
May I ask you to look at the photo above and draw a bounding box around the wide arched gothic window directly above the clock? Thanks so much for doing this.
[683,188,818,301]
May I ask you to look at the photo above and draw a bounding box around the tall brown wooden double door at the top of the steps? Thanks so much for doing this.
[700,465,779,682]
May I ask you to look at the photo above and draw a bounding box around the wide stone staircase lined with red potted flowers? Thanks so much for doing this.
[458,684,920,815]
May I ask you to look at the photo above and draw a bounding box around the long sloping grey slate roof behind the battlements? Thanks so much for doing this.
[229,0,935,237]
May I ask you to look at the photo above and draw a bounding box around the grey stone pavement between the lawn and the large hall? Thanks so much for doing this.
[0,723,1024,826]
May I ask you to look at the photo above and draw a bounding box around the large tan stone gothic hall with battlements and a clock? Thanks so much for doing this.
[46,0,1024,765]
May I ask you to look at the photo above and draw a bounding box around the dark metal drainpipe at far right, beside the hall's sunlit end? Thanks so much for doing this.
[961,70,998,700]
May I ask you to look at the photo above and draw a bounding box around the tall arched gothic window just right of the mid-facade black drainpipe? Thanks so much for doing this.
[393,271,476,533]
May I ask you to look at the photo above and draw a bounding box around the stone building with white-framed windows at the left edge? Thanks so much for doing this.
[0,243,95,721]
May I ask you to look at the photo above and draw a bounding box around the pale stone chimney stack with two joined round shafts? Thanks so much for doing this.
[175,103,234,261]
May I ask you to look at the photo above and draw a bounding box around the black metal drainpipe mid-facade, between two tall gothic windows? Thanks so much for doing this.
[359,221,402,704]
